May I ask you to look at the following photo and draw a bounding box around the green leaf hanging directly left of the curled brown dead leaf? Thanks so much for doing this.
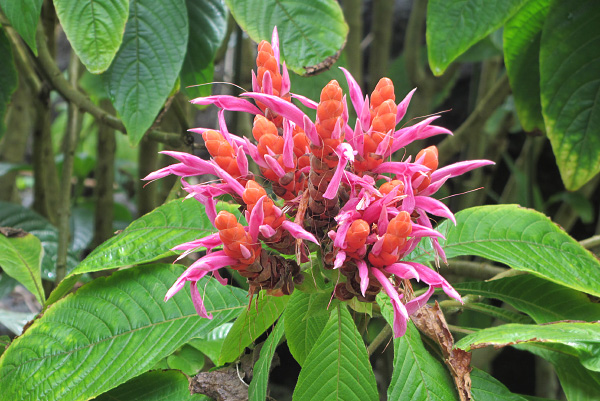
[377,294,458,401]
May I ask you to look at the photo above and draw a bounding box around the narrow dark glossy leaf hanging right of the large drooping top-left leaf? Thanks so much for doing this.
[181,0,227,98]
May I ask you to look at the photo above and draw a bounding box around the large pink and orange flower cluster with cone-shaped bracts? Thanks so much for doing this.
[145,29,492,337]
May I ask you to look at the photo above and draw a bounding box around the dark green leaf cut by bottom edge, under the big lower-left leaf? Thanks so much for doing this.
[94,370,208,401]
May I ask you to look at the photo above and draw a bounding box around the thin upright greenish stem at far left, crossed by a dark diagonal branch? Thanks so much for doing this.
[54,52,81,287]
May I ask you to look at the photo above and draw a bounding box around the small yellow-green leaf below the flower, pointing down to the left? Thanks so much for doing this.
[219,292,290,365]
